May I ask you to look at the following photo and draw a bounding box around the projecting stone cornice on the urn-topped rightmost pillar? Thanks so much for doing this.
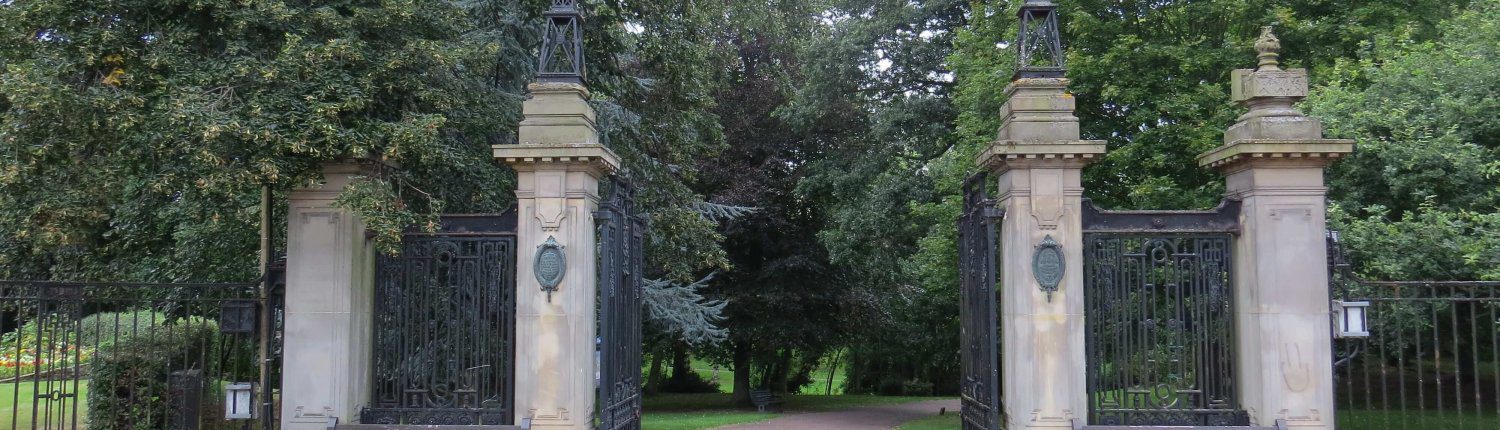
[1199,139,1355,169]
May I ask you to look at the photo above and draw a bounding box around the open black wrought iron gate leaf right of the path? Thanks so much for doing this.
[959,172,1002,430]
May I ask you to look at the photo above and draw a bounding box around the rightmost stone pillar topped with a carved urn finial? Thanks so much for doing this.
[1199,28,1353,429]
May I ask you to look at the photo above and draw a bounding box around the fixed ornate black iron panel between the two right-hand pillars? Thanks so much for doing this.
[1083,201,1250,426]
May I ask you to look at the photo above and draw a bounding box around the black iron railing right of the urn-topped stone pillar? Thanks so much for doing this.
[1329,234,1500,430]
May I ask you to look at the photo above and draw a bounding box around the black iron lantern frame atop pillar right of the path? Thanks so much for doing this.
[1014,0,1067,79]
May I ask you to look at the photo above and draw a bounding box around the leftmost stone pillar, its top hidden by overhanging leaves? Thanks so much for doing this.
[281,162,375,430]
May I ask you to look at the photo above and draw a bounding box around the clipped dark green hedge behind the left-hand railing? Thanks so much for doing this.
[89,319,222,430]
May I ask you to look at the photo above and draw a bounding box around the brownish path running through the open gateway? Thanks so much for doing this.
[714,399,959,430]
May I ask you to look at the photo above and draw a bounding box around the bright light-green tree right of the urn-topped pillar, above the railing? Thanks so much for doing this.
[1304,0,1500,280]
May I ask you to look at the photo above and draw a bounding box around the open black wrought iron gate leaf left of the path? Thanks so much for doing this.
[594,177,647,430]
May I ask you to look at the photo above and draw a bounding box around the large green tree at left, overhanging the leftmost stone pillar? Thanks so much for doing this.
[0,0,738,280]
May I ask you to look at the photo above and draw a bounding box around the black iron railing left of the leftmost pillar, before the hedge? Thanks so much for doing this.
[0,280,282,429]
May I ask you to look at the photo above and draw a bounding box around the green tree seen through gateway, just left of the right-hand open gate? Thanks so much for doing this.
[779,0,971,394]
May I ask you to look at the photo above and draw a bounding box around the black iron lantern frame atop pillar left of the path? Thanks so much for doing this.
[537,0,585,84]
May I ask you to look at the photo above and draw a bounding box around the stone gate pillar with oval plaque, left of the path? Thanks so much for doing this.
[494,82,620,430]
